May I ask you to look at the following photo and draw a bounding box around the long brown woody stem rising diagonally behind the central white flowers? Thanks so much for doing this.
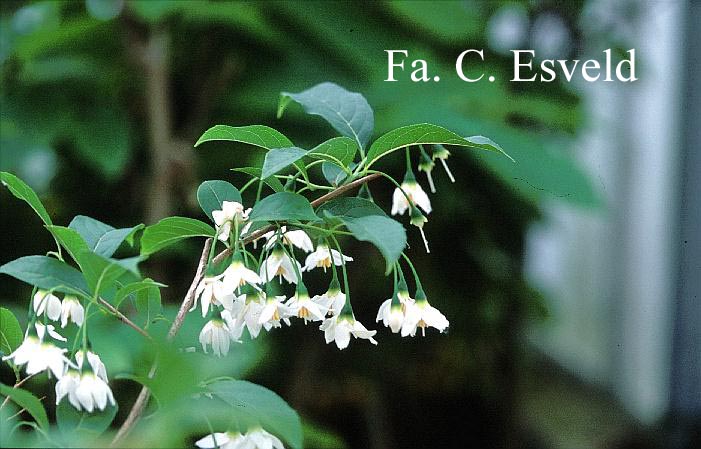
[110,173,380,447]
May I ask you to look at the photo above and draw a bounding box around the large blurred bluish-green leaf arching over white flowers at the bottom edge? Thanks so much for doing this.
[207,380,302,449]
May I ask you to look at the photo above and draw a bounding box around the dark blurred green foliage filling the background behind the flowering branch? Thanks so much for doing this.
[0,0,636,448]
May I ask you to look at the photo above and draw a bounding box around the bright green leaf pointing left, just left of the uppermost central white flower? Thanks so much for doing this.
[141,217,214,255]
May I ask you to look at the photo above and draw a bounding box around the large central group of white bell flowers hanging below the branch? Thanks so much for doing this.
[191,198,448,357]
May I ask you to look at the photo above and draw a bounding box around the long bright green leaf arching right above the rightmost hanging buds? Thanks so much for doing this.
[367,123,510,167]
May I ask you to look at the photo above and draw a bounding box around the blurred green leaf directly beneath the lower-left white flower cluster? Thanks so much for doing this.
[56,398,118,442]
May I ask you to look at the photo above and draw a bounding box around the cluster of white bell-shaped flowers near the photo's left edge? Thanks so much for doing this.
[2,290,115,413]
